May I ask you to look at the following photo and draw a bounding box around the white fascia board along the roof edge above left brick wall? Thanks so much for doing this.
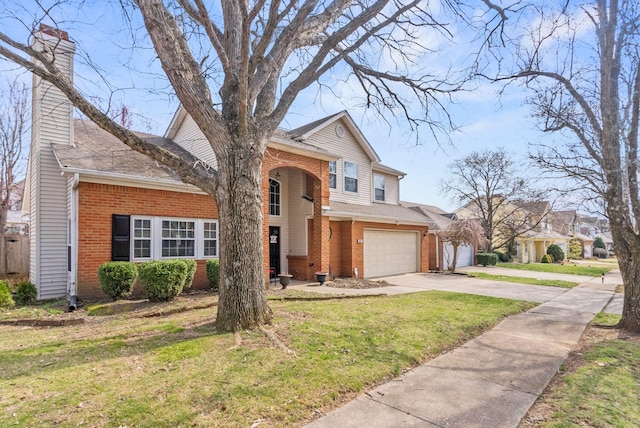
[61,168,207,195]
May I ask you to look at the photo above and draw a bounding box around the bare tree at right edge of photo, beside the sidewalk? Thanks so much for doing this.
[495,0,640,332]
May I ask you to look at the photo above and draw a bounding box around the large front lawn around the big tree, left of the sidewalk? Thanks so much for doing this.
[0,292,533,427]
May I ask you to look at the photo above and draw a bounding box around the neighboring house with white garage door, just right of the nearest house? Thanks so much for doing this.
[402,201,477,271]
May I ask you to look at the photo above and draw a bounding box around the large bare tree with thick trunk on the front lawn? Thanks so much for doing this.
[0,0,504,330]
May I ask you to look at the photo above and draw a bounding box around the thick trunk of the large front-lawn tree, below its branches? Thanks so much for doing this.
[216,141,272,331]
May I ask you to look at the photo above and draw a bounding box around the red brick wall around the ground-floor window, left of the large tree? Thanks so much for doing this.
[78,182,218,297]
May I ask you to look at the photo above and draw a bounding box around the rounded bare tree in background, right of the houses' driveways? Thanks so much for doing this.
[441,148,550,252]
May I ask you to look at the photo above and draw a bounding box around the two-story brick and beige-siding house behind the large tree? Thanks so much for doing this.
[26,29,429,299]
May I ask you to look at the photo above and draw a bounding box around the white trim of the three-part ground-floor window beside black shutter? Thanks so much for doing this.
[129,216,220,262]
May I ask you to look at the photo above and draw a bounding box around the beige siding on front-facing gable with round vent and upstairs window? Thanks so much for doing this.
[307,120,372,205]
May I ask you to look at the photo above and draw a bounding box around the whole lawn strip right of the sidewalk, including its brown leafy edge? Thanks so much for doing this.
[523,315,640,427]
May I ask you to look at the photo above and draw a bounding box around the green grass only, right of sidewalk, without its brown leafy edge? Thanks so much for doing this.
[541,316,640,427]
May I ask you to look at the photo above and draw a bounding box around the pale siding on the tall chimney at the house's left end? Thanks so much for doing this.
[30,35,74,299]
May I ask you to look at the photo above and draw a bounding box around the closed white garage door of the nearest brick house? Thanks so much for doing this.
[364,230,420,278]
